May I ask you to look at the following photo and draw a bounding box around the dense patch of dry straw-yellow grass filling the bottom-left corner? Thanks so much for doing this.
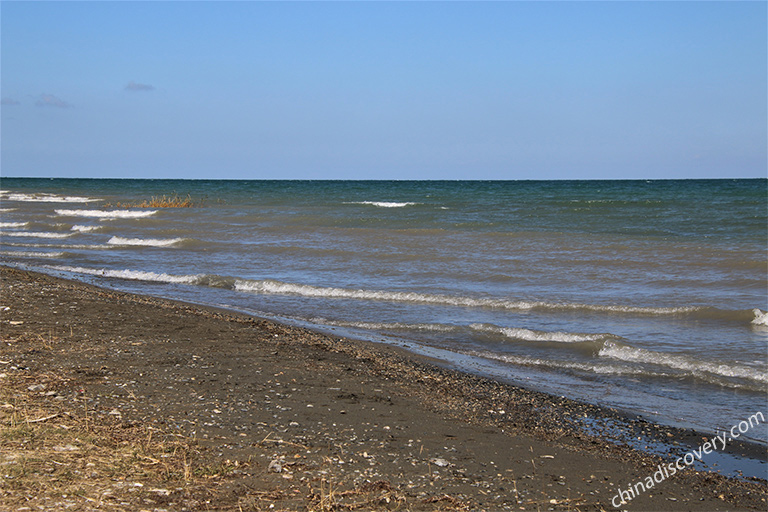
[0,374,230,510]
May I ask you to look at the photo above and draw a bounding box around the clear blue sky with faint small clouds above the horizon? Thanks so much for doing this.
[0,1,768,179]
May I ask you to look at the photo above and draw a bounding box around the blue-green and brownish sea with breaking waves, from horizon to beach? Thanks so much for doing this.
[0,178,768,450]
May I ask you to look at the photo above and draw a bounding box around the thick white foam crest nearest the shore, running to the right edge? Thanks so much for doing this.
[598,341,768,383]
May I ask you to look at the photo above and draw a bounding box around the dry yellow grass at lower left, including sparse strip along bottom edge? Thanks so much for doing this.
[0,371,432,512]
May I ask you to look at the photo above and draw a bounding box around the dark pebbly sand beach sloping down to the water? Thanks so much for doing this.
[0,267,768,511]
